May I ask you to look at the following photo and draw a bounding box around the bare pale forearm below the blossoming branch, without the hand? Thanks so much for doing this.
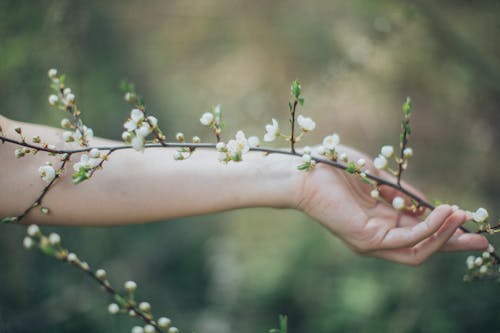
[0,115,301,225]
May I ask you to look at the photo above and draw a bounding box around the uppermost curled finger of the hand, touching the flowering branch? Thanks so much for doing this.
[378,205,454,249]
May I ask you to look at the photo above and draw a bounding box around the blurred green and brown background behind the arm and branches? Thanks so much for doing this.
[0,0,500,333]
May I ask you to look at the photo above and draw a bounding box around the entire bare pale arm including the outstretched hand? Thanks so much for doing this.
[0,116,488,265]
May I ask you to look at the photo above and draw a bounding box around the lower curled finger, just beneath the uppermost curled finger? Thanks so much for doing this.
[372,211,468,265]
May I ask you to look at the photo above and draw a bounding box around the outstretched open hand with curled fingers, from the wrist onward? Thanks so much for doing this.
[298,147,489,265]
